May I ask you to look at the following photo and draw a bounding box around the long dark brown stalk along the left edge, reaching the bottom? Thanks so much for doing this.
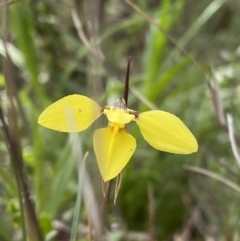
[0,4,43,241]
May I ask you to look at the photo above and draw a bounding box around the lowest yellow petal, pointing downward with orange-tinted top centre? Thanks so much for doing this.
[93,125,136,182]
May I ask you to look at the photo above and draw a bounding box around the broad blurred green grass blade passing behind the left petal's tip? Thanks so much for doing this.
[10,1,46,213]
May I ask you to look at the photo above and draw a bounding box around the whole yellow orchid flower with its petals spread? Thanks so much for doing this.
[38,94,198,182]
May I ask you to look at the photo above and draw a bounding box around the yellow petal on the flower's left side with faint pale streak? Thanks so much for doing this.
[38,95,101,132]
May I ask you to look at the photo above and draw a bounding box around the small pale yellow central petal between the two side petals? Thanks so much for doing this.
[103,109,135,125]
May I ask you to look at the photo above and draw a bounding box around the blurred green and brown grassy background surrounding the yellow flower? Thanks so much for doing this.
[0,0,240,241]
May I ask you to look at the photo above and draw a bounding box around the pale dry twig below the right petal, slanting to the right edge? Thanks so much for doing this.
[183,165,240,193]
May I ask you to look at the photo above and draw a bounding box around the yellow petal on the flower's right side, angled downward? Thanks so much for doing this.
[136,110,198,154]
